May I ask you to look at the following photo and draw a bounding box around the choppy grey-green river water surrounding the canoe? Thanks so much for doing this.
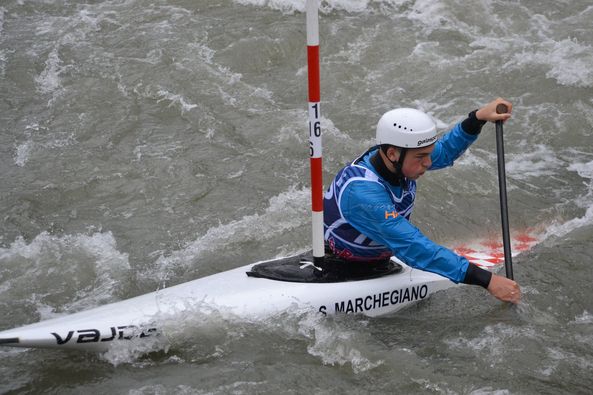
[0,0,593,395]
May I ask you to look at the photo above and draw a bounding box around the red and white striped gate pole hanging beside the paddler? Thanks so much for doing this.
[307,0,325,263]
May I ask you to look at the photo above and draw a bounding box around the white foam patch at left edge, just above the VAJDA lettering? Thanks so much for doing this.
[0,232,130,319]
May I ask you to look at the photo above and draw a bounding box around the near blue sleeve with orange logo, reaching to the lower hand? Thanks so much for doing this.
[340,181,469,283]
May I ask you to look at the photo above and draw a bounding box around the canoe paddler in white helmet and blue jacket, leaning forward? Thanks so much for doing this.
[324,98,521,303]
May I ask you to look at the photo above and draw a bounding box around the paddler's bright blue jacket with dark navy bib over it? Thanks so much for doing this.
[324,124,477,283]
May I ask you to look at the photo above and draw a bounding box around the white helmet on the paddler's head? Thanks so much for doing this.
[377,108,437,148]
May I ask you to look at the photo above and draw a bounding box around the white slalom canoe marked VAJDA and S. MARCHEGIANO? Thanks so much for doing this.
[0,230,538,351]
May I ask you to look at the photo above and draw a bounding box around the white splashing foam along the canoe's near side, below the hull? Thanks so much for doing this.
[102,290,385,374]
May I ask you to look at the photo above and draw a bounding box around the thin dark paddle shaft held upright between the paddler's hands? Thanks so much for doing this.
[496,103,513,280]
